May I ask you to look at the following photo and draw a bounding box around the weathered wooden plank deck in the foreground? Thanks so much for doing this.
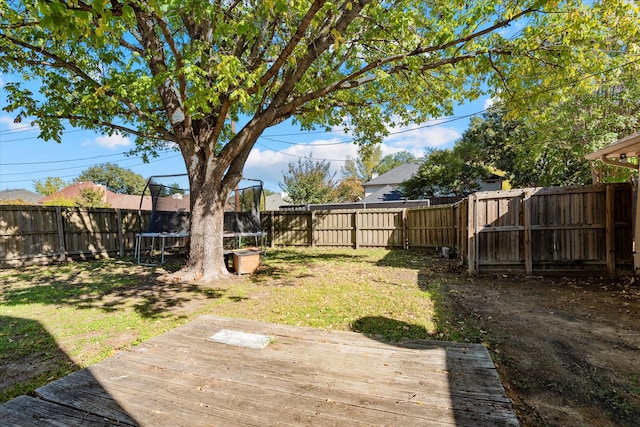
[0,316,518,427]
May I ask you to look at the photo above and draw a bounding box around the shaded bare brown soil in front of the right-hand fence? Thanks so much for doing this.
[448,276,640,426]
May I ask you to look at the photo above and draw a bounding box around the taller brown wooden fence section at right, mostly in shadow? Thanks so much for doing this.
[468,184,634,277]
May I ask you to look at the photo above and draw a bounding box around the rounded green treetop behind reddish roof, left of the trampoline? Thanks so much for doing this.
[74,163,147,195]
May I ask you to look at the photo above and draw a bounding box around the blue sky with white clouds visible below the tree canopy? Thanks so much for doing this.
[0,74,487,192]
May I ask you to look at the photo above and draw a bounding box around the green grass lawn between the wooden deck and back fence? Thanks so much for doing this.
[0,248,475,402]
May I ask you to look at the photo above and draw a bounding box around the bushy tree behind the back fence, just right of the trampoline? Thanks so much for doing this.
[279,157,337,204]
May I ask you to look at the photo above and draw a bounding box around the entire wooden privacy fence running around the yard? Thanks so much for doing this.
[0,184,634,276]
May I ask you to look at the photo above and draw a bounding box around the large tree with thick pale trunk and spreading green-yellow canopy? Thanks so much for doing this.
[0,0,638,279]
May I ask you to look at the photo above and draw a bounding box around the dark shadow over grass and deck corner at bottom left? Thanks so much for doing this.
[0,316,139,427]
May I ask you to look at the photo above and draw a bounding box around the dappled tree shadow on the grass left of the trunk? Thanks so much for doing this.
[0,260,225,318]
